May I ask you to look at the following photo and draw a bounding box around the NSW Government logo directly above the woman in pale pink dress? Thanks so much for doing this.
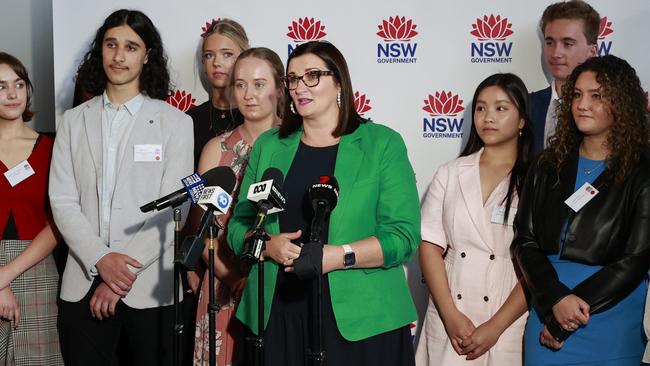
[470,14,514,64]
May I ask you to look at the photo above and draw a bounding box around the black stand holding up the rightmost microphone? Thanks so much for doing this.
[307,200,330,366]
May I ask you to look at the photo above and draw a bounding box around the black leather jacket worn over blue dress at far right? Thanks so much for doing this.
[511,150,650,325]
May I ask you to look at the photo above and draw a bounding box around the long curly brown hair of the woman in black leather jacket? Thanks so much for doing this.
[542,55,650,184]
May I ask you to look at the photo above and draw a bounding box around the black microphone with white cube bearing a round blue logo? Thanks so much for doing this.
[176,166,237,270]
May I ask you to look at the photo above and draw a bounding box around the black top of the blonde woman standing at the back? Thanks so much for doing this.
[186,100,244,170]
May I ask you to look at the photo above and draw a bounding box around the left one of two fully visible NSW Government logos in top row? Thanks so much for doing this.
[377,15,418,64]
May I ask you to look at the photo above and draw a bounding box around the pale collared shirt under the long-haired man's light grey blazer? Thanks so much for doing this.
[99,91,144,246]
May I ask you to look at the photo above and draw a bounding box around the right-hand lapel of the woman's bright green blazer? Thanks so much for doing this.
[328,125,364,241]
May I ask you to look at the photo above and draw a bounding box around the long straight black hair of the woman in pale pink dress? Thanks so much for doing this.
[460,73,534,223]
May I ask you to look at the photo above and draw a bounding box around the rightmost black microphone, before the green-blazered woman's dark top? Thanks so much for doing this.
[309,175,339,244]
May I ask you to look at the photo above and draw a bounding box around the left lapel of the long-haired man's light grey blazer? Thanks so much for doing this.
[83,95,104,196]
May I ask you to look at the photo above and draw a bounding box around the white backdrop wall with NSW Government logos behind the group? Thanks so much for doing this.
[53,0,650,340]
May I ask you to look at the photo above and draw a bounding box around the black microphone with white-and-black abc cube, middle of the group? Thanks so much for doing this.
[241,168,287,264]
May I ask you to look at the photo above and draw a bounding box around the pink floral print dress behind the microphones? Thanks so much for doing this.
[193,126,252,366]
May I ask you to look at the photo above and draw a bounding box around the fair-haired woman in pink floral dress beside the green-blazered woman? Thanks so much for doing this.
[194,47,285,366]
